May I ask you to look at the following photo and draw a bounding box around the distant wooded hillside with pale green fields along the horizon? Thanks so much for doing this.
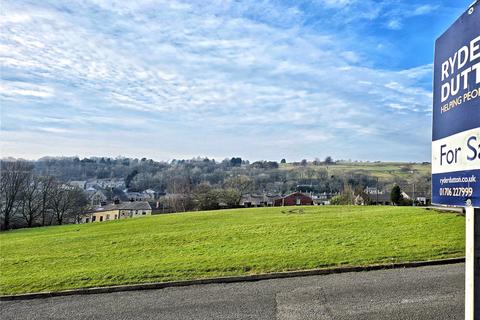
[3,157,431,194]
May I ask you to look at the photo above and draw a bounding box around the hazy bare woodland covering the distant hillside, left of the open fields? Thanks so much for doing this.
[25,157,358,193]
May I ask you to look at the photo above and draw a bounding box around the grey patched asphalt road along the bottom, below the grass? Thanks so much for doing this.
[0,264,464,320]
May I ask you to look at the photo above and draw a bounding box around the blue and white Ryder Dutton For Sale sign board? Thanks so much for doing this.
[432,2,480,207]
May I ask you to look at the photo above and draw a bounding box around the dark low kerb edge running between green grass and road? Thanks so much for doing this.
[0,258,465,301]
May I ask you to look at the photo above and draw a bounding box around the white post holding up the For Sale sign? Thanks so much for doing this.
[465,207,480,320]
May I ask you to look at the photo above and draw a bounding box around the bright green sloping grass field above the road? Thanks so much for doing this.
[0,206,464,294]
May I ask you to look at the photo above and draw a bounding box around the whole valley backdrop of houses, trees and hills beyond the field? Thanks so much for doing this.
[1,157,430,229]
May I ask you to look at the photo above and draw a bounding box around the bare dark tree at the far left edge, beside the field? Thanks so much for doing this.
[0,161,32,230]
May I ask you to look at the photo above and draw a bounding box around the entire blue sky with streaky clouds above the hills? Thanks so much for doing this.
[0,0,471,161]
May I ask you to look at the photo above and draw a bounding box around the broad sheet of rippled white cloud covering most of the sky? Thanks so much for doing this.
[0,1,436,160]
